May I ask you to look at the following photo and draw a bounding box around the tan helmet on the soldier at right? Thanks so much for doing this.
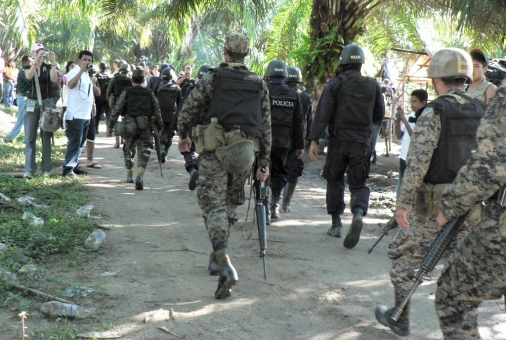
[427,48,473,81]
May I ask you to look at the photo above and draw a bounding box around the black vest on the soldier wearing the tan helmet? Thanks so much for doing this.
[422,95,485,184]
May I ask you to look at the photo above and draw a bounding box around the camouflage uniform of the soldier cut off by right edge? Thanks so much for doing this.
[432,83,506,340]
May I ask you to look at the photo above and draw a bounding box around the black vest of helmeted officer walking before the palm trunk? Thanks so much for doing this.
[331,74,378,131]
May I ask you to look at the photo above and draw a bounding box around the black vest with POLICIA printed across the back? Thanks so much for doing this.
[267,83,299,136]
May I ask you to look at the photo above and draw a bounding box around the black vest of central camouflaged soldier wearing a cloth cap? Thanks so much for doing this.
[204,67,263,137]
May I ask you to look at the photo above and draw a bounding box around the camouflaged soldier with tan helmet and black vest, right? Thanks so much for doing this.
[375,48,484,336]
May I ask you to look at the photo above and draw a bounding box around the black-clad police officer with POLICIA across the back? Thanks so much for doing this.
[265,60,304,224]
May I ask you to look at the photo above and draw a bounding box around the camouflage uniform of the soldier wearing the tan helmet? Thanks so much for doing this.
[388,89,478,310]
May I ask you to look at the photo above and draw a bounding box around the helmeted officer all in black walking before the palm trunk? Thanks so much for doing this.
[309,44,385,248]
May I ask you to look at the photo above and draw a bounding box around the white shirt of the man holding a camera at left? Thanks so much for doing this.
[65,67,95,120]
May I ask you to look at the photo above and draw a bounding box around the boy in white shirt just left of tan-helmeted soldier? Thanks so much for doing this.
[395,89,429,198]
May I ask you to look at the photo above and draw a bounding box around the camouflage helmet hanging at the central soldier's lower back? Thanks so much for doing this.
[215,139,255,174]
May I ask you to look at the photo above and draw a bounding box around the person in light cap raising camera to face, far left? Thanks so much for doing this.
[23,44,58,178]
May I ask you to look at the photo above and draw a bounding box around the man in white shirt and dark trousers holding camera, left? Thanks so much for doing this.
[63,51,100,177]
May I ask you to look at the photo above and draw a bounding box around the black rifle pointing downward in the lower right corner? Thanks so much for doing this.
[392,212,469,321]
